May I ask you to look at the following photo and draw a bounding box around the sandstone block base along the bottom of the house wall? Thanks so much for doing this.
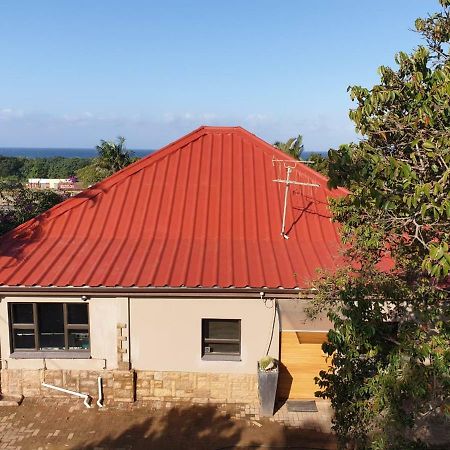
[1,369,258,403]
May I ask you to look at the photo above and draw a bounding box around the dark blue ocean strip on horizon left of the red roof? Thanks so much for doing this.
[0,147,154,158]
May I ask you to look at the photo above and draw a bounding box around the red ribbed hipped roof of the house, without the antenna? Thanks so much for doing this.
[0,127,346,288]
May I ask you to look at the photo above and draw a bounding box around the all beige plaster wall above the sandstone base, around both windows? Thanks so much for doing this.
[0,296,279,374]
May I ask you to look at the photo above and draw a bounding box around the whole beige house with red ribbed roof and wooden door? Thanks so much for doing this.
[0,127,346,402]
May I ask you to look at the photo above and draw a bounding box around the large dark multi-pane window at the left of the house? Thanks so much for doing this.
[9,303,89,356]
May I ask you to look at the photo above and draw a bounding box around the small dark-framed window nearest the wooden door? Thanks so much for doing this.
[202,319,241,361]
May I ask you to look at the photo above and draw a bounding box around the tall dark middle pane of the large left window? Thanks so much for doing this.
[38,303,65,350]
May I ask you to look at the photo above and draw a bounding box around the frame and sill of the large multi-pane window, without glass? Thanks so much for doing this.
[8,301,91,359]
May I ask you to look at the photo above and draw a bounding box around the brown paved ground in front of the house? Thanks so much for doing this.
[0,399,335,450]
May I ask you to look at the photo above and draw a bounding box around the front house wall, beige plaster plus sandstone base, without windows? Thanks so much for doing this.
[0,296,279,403]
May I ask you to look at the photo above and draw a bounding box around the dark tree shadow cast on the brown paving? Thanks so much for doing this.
[76,405,336,450]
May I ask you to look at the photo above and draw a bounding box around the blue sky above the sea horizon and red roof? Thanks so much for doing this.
[0,0,438,151]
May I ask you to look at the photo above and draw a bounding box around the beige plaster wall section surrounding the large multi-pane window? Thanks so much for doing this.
[0,296,128,370]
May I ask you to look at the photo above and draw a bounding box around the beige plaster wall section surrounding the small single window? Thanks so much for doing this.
[130,298,279,374]
